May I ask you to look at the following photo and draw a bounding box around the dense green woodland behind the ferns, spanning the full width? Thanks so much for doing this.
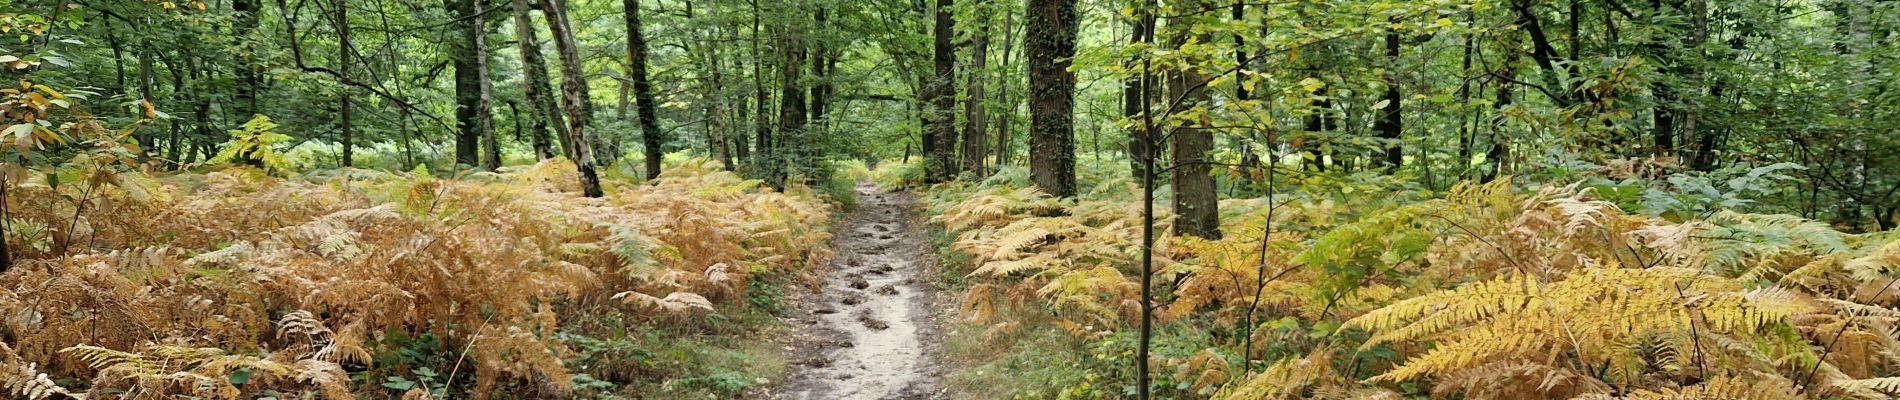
[8,0,1900,229]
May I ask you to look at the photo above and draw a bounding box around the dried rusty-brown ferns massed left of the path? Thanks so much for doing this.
[0,161,832,398]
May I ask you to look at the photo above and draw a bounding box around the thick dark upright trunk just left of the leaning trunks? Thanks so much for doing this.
[443,0,488,165]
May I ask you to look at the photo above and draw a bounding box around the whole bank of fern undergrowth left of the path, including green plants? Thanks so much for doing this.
[0,159,834,400]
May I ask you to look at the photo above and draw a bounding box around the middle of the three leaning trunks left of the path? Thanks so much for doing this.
[542,0,602,197]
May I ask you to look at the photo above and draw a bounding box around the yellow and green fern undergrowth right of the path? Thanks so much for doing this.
[925,162,1900,398]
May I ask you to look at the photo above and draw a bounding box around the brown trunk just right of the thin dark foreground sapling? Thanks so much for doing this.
[1165,0,1220,239]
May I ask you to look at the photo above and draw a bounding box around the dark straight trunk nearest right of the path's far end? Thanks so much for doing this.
[925,0,960,182]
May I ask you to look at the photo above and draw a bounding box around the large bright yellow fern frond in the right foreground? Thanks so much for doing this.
[1345,267,1807,381]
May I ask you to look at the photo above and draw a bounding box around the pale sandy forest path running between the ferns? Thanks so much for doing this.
[777,182,944,400]
